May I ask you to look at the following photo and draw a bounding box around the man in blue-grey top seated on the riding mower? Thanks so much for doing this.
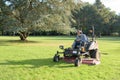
[72,30,88,49]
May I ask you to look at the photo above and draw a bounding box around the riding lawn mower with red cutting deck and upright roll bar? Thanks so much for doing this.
[53,27,100,66]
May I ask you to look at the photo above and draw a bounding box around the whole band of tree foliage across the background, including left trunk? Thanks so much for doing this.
[0,0,120,40]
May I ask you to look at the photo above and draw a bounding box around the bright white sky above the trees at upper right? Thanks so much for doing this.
[82,0,120,14]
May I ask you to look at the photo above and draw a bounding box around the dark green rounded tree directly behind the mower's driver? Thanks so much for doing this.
[73,3,102,32]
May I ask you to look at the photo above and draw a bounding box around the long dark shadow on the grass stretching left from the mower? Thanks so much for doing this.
[0,58,70,68]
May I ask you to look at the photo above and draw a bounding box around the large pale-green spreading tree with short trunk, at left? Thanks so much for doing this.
[1,0,81,40]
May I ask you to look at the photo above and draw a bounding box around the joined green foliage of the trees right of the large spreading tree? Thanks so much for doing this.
[72,0,116,35]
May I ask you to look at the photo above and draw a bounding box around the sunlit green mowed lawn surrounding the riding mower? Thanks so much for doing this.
[0,36,120,80]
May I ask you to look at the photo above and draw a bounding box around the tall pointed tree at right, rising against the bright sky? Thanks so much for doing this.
[93,0,115,35]
